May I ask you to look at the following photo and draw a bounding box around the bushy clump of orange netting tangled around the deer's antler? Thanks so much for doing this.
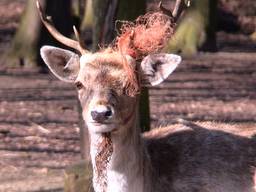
[116,12,174,59]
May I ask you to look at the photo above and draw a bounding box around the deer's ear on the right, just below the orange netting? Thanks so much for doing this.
[141,53,181,86]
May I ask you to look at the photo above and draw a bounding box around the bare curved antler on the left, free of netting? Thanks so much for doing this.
[36,0,88,54]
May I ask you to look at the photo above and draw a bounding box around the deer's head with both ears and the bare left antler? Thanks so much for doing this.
[37,2,181,133]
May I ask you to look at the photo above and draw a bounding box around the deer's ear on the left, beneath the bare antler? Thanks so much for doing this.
[40,46,79,82]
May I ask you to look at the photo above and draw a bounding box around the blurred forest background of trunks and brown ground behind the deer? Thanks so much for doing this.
[0,0,256,192]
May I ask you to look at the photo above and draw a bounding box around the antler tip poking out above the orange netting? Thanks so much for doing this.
[158,0,190,22]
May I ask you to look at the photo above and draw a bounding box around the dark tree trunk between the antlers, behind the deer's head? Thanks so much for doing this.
[92,0,146,50]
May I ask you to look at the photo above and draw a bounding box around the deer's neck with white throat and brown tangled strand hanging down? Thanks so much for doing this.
[91,105,148,192]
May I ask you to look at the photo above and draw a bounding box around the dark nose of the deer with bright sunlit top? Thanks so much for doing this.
[91,105,113,123]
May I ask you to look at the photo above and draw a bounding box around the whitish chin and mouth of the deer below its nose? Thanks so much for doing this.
[87,122,116,134]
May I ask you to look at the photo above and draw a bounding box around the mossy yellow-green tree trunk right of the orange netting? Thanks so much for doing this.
[166,0,217,56]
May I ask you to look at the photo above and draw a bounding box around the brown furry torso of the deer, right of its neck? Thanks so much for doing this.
[145,123,256,192]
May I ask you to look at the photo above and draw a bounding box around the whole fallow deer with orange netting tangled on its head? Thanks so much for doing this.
[37,2,256,192]
